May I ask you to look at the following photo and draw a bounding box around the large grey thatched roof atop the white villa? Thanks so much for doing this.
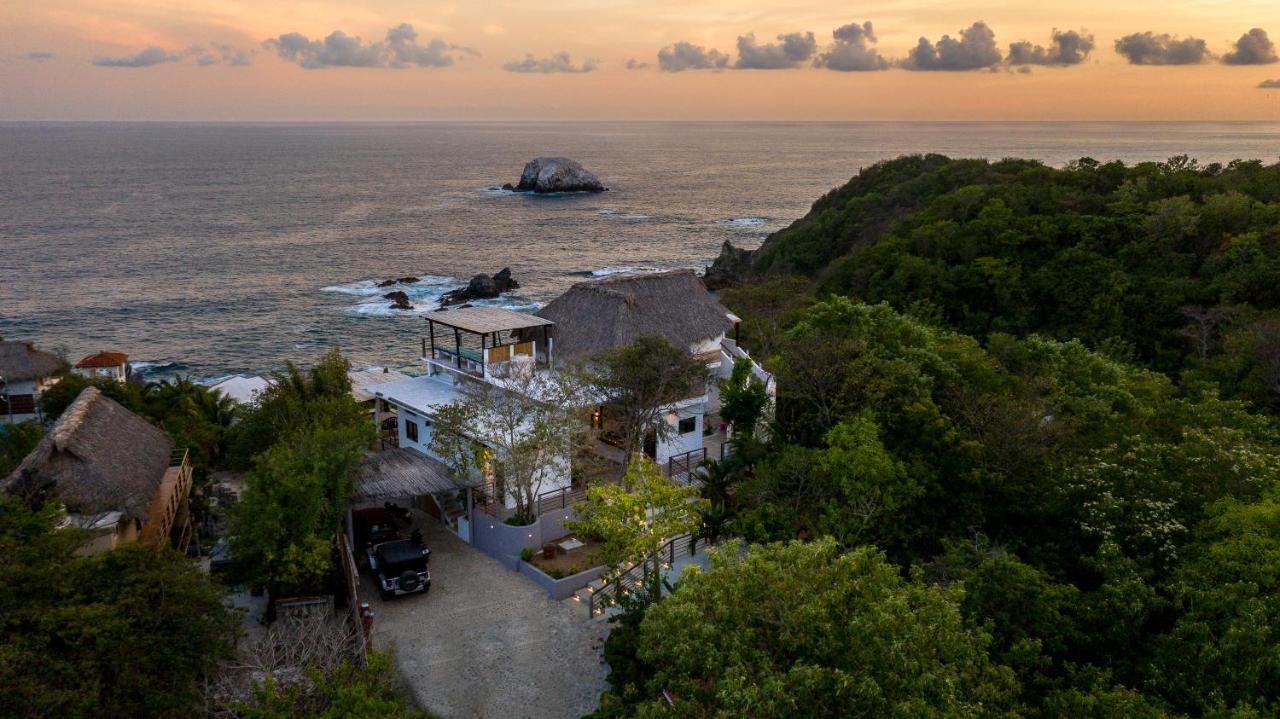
[536,270,733,357]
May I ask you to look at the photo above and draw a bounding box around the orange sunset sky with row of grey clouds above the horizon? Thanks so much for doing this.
[0,0,1280,120]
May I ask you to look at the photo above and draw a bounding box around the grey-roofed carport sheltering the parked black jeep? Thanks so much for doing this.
[347,446,483,542]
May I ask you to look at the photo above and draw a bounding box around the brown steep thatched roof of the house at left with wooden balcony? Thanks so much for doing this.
[5,386,174,519]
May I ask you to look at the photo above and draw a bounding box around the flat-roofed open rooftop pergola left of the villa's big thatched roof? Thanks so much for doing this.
[422,307,554,376]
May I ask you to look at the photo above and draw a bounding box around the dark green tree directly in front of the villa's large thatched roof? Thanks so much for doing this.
[594,336,707,457]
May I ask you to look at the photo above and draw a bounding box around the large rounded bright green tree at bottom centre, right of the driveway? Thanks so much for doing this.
[635,541,1018,718]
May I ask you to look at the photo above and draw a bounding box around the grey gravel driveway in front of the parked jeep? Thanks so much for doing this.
[361,519,608,719]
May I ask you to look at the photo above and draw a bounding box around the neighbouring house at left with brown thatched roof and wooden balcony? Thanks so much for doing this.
[4,386,191,554]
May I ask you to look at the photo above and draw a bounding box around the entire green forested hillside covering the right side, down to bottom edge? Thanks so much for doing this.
[599,156,1280,719]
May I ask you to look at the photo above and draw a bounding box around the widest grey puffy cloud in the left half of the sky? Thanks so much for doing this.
[262,23,477,70]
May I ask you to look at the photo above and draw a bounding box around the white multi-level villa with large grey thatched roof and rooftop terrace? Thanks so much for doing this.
[362,270,773,541]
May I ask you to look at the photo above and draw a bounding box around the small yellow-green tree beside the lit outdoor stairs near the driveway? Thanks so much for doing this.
[566,455,707,600]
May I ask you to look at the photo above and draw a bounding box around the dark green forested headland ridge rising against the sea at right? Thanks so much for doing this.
[732,155,1280,409]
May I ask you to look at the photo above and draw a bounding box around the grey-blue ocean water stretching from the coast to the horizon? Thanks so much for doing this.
[0,123,1280,379]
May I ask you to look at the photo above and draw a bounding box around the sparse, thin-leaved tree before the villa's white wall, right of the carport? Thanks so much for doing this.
[431,363,589,523]
